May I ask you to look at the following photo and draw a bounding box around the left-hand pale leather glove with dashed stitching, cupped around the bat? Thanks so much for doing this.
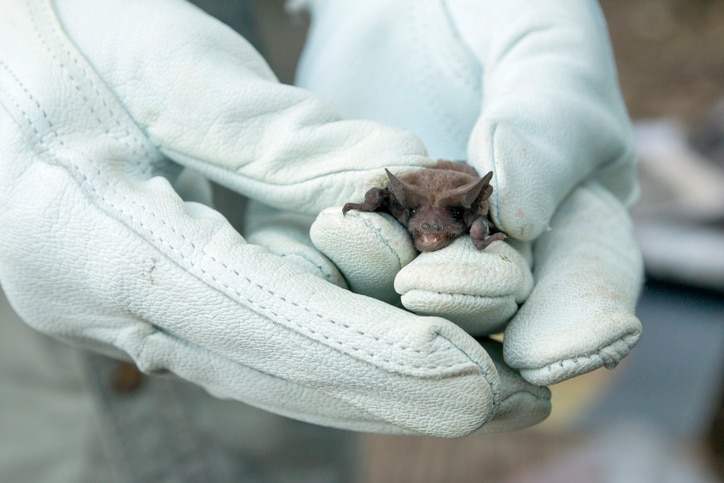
[0,0,550,436]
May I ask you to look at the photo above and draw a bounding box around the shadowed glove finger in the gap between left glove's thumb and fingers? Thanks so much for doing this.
[244,200,347,288]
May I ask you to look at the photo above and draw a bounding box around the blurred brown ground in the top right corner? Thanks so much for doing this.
[601,0,724,127]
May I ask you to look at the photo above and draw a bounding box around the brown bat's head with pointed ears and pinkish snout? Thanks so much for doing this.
[387,170,487,252]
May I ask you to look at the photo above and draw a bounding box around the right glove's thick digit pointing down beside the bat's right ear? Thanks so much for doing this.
[447,0,636,240]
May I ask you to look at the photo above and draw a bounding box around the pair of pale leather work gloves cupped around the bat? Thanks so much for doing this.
[0,0,642,437]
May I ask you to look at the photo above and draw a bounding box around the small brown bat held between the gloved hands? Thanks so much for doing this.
[342,160,506,252]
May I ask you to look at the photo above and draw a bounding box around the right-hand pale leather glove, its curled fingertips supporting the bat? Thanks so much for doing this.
[298,0,642,385]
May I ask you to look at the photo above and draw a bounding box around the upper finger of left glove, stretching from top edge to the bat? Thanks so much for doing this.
[52,0,431,214]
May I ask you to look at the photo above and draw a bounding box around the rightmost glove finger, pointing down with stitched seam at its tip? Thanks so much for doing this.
[504,182,643,385]
